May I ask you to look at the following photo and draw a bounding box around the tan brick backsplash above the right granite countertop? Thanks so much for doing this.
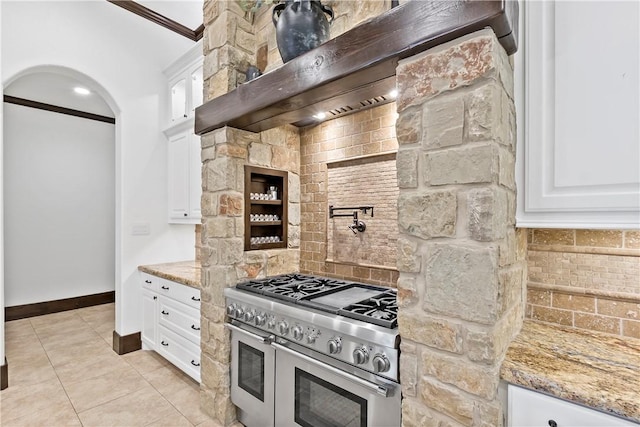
[526,229,640,339]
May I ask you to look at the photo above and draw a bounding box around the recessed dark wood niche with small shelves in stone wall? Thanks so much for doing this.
[244,166,288,251]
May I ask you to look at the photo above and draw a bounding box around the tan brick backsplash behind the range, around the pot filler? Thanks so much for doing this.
[300,103,398,287]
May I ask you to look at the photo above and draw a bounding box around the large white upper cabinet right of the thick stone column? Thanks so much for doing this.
[515,1,640,228]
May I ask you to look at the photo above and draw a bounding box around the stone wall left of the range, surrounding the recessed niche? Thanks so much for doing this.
[198,0,300,425]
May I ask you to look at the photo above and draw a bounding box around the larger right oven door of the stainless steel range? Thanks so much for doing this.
[271,341,401,427]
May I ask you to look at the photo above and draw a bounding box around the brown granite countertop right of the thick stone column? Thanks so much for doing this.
[500,321,640,422]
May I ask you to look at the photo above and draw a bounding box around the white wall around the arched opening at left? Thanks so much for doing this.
[1,1,194,335]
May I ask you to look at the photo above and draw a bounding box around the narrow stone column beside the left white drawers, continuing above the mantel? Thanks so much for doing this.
[200,0,260,425]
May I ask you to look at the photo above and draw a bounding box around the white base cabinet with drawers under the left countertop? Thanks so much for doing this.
[141,273,200,382]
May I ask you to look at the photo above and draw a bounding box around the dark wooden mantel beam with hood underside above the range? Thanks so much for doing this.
[195,0,518,135]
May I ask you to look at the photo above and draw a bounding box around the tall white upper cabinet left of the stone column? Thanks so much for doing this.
[164,42,203,224]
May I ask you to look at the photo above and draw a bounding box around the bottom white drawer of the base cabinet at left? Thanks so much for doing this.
[156,325,200,382]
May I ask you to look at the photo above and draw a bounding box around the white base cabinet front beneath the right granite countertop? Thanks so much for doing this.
[507,385,638,427]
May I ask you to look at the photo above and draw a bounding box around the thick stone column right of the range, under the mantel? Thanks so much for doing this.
[396,29,526,427]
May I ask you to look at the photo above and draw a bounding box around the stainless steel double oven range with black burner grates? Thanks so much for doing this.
[225,274,401,427]
